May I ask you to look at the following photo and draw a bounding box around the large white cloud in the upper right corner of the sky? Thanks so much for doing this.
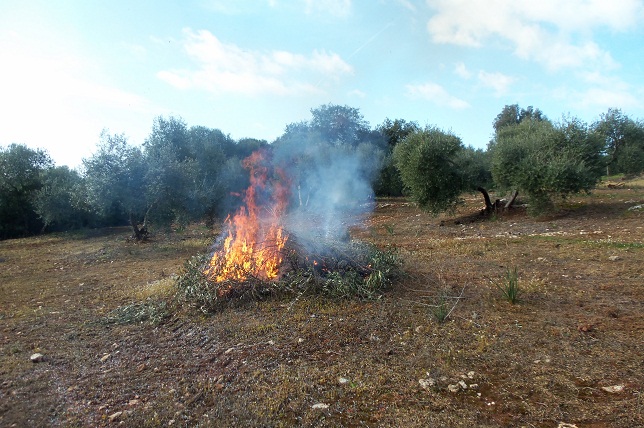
[427,0,644,70]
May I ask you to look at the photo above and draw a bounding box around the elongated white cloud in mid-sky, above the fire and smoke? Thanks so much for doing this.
[157,29,353,95]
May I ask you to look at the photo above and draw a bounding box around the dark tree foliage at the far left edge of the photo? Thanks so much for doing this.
[0,144,53,239]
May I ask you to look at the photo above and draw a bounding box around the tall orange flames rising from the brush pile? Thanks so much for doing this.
[204,151,289,282]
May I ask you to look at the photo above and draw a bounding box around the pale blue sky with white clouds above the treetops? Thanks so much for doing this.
[0,0,644,167]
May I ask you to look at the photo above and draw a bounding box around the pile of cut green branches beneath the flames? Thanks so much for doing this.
[176,235,402,312]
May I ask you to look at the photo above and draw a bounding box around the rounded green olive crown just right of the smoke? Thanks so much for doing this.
[394,127,467,214]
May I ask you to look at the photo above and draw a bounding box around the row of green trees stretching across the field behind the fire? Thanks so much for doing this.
[0,104,644,239]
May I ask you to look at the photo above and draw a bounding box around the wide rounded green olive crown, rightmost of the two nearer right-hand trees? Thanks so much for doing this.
[492,119,602,213]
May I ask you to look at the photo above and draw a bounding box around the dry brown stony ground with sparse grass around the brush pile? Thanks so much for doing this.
[0,180,644,428]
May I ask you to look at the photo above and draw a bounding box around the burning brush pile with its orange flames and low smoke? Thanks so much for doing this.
[177,152,401,311]
